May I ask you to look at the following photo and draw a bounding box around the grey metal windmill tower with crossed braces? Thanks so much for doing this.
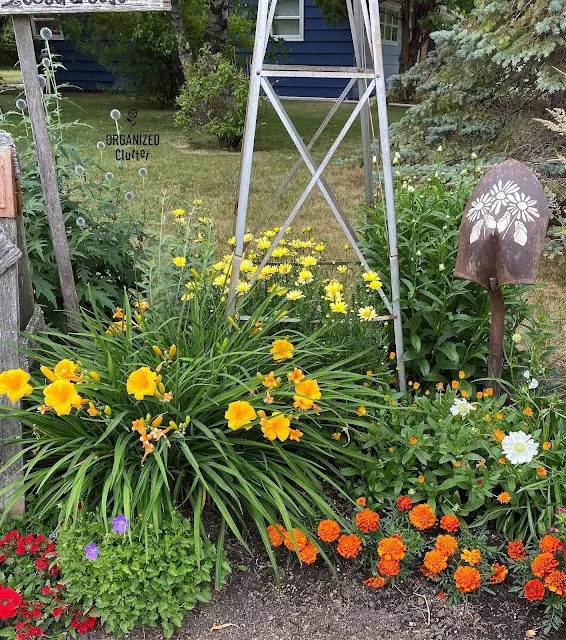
[228,0,406,391]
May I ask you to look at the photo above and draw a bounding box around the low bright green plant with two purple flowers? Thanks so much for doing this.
[57,514,229,638]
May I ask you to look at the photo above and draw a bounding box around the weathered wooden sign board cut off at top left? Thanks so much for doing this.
[0,0,171,15]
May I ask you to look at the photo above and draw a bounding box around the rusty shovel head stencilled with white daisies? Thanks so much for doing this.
[454,160,548,289]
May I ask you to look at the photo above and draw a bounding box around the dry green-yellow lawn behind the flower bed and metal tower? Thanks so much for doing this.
[0,92,403,258]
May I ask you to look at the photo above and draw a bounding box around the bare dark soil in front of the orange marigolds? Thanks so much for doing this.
[98,545,566,640]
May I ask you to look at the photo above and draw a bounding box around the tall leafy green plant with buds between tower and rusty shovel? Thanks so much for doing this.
[363,165,528,383]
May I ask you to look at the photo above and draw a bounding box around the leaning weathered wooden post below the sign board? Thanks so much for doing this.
[12,15,79,327]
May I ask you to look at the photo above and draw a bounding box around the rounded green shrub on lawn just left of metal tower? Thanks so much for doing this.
[175,50,249,149]
